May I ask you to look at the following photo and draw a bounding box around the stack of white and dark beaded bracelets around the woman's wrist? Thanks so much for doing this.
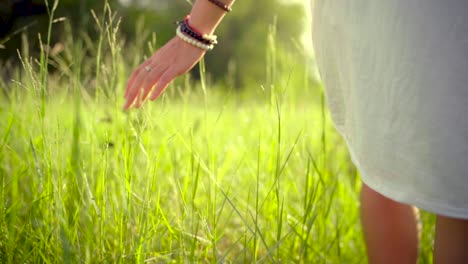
[176,16,218,50]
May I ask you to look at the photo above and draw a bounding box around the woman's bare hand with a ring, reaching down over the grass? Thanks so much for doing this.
[124,37,206,109]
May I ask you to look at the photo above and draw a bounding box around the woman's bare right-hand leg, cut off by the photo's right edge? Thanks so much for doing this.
[434,215,468,264]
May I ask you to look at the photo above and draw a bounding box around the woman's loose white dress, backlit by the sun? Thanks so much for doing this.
[313,0,468,219]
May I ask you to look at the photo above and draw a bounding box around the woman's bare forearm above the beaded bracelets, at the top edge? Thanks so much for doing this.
[190,0,235,35]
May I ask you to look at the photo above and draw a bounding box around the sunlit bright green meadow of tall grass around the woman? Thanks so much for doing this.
[0,3,434,263]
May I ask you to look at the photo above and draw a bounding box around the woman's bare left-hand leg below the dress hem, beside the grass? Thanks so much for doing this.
[361,184,419,264]
